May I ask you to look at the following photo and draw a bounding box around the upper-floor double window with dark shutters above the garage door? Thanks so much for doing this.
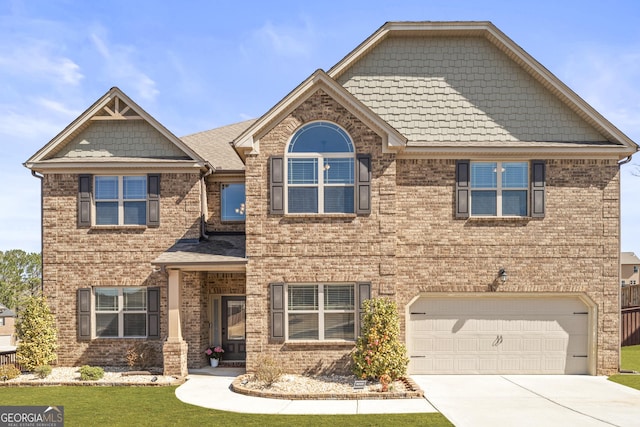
[471,162,529,216]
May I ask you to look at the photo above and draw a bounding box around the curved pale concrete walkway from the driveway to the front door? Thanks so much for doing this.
[176,368,437,415]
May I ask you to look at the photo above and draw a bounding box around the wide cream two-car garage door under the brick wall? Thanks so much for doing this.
[407,296,589,374]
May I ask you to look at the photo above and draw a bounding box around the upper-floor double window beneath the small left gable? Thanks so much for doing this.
[94,176,147,225]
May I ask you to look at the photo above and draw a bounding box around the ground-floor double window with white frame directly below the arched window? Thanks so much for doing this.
[287,284,356,340]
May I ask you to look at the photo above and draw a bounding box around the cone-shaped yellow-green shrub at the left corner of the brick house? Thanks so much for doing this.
[16,296,58,371]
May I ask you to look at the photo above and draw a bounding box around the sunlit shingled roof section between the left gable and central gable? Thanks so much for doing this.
[180,119,256,172]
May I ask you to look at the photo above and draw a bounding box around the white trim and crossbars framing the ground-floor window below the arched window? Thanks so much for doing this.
[284,283,360,343]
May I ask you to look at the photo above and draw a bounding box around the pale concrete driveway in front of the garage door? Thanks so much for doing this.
[411,375,640,427]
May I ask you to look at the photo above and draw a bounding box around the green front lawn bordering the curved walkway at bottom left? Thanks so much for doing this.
[0,386,452,427]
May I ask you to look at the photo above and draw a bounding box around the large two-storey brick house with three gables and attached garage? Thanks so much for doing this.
[25,22,638,375]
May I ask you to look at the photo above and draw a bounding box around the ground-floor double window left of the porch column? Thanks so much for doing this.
[94,287,147,338]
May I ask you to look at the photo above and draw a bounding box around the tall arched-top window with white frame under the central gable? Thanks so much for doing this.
[285,122,355,213]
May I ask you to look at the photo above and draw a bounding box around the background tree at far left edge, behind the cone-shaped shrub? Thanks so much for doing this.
[0,249,42,309]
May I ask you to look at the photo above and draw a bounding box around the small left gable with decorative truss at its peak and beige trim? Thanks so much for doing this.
[24,87,208,171]
